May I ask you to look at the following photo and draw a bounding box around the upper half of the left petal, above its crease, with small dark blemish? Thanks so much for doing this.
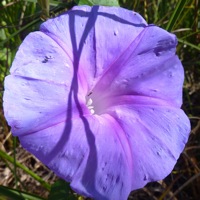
[10,31,74,86]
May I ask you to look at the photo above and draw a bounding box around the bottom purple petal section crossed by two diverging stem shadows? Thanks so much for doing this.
[19,115,132,200]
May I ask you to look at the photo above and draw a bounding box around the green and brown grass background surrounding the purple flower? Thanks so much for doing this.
[0,0,200,200]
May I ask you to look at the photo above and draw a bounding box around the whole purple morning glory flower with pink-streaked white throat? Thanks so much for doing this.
[4,6,190,200]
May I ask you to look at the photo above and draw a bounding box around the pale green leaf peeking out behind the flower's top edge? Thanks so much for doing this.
[75,0,119,6]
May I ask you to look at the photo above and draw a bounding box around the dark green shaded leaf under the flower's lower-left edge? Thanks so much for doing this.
[48,180,76,200]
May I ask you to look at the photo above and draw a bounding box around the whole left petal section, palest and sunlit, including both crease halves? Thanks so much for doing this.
[3,32,89,136]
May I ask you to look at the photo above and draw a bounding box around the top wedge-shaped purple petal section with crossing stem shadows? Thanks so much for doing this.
[41,6,147,90]
